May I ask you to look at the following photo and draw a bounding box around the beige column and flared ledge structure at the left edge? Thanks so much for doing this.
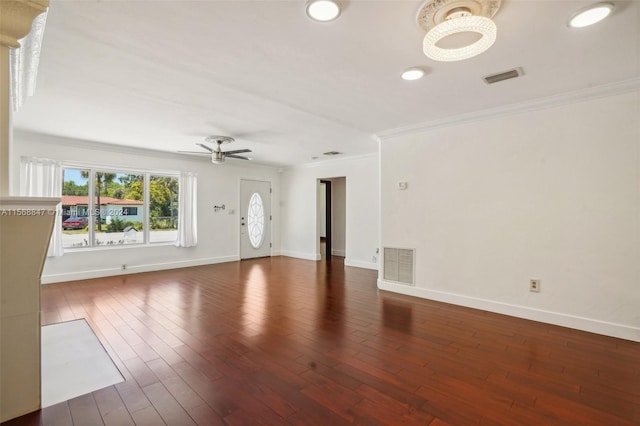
[0,0,49,422]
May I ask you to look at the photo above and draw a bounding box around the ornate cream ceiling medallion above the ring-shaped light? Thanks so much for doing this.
[416,0,501,32]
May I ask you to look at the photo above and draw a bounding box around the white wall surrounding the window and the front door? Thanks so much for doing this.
[12,131,280,283]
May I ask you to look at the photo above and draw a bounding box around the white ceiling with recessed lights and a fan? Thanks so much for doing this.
[14,0,640,166]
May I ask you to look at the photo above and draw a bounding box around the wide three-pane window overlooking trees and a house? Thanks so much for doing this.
[61,168,179,248]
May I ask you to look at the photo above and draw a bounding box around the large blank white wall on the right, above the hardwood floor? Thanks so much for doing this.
[379,91,640,341]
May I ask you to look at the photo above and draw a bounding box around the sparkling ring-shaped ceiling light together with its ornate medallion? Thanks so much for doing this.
[417,0,500,62]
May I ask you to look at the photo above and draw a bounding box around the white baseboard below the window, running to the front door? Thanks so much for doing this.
[40,256,240,284]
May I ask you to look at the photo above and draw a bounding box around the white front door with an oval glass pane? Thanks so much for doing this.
[240,179,271,259]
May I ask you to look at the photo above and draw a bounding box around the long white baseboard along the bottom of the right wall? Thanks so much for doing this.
[378,279,640,342]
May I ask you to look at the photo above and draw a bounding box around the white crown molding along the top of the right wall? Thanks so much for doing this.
[376,78,640,141]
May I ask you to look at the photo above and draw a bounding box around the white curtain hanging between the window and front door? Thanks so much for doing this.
[176,172,198,247]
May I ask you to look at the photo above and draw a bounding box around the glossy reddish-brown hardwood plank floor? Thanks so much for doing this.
[3,257,640,426]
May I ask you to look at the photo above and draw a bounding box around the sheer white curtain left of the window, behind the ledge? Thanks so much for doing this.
[20,157,64,256]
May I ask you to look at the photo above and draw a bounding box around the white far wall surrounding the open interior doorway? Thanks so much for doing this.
[281,154,379,269]
